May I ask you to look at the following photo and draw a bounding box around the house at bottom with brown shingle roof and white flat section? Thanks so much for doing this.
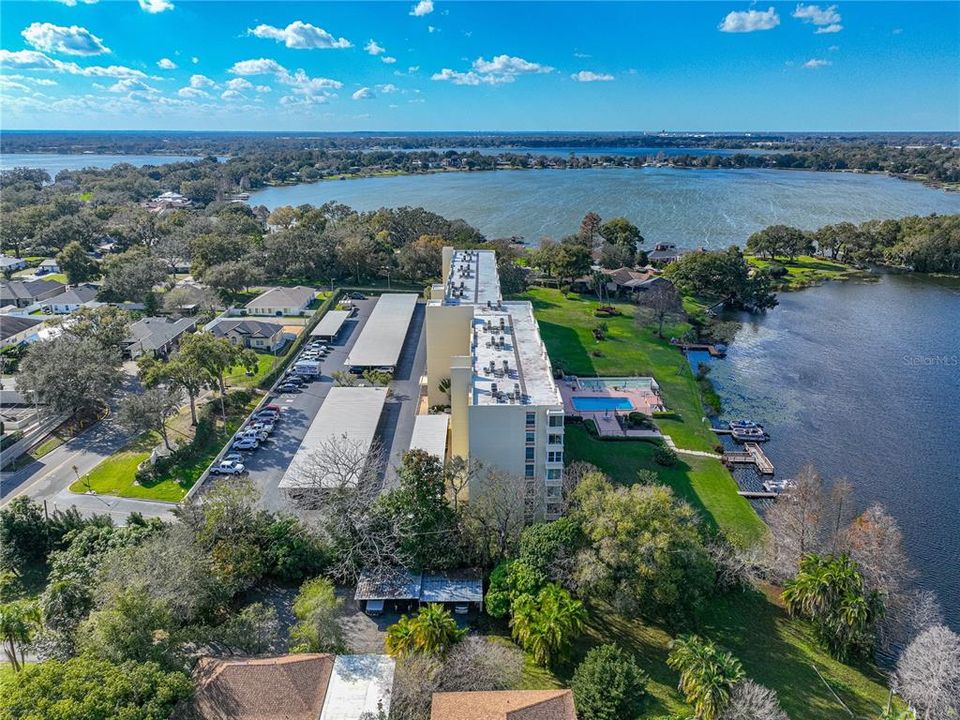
[173,653,395,720]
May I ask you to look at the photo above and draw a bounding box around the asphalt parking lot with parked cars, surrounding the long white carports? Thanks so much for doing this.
[225,298,426,511]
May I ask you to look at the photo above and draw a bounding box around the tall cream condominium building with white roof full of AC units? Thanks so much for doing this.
[426,248,563,517]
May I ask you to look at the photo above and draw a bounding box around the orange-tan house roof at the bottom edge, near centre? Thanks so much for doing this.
[430,690,577,720]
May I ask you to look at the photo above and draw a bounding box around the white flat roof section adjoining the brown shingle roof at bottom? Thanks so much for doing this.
[320,655,396,720]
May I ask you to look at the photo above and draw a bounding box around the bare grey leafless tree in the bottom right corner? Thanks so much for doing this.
[892,625,960,720]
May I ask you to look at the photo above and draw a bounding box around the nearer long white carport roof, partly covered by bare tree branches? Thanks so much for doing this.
[280,387,387,489]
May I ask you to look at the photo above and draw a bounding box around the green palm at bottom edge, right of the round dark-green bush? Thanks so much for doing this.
[667,635,744,720]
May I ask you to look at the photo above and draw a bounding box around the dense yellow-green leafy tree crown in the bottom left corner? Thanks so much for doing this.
[0,657,193,720]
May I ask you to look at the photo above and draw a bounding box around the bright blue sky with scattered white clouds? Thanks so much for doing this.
[0,0,960,131]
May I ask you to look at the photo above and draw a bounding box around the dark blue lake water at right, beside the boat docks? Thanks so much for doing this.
[691,275,960,629]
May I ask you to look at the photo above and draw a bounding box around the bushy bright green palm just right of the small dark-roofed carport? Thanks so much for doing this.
[510,583,587,666]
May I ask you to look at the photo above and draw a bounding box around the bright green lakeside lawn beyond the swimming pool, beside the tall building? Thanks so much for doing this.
[522,288,717,450]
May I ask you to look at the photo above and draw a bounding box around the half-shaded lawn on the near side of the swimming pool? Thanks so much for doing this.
[564,424,766,546]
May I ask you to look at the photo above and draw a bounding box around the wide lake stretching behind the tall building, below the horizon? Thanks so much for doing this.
[250,168,960,248]
